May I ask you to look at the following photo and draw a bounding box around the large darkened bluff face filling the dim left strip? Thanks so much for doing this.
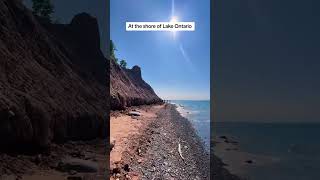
[0,0,109,150]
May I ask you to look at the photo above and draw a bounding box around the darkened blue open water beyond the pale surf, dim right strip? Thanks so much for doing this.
[215,123,320,180]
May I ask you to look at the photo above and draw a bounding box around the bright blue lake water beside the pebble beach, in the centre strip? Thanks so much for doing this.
[171,100,210,150]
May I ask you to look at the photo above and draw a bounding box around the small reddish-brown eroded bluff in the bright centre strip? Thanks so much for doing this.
[110,60,162,110]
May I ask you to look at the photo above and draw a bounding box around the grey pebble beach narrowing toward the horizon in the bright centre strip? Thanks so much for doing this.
[111,104,210,179]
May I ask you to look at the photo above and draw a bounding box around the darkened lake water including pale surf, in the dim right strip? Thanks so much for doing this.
[214,122,320,180]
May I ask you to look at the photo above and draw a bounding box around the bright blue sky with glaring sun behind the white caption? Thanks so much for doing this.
[110,0,210,100]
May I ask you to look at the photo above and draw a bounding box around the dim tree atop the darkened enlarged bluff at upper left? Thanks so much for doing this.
[32,0,54,22]
